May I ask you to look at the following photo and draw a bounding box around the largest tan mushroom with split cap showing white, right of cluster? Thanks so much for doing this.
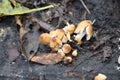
[74,20,93,41]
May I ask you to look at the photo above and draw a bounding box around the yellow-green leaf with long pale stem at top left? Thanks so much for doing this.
[0,0,54,16]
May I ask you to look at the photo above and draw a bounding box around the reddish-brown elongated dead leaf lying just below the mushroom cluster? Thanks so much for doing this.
[31,53,64,65]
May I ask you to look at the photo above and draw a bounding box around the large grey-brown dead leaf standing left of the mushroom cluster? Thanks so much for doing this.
[21,26,39,60]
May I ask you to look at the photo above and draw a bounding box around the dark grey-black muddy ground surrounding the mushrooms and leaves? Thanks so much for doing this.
[0,0,120,80]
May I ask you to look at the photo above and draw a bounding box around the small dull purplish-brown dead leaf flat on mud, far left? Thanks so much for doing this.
[7,49,20,62]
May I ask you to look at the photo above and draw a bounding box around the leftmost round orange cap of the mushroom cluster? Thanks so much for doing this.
[39,33,50,44]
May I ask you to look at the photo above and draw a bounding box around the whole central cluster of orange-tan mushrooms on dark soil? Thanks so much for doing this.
[39,20,93,64]
